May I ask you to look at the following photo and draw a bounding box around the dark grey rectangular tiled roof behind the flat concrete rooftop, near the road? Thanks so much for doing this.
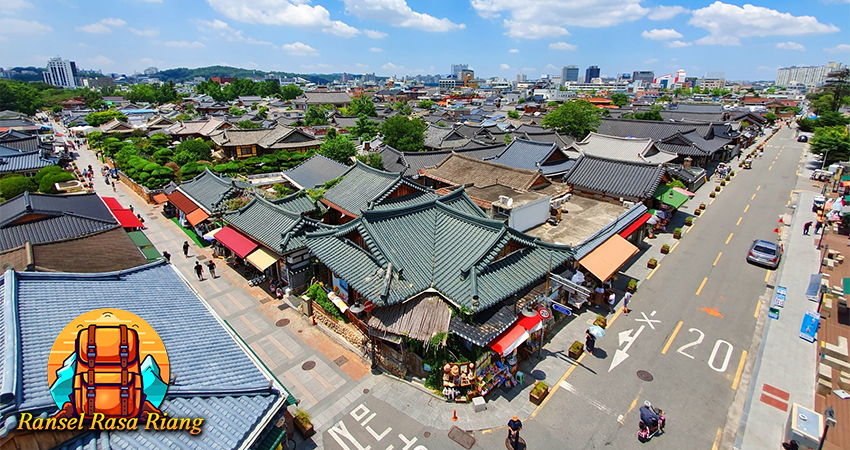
[564,155,664,199]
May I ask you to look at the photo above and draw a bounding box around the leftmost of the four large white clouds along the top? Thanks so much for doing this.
[207,0,360,38]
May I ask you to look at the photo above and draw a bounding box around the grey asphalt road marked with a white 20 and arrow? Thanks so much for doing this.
[479,128,803,449]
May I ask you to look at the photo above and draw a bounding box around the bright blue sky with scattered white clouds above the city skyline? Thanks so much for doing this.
[0,0,850,80]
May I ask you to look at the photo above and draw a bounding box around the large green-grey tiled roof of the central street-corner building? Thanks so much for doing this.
[307,190,573,313]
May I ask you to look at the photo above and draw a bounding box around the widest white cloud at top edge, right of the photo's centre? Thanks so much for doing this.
[470,0,650,39]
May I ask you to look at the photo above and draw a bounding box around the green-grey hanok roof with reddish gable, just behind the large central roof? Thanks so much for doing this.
[321,161,437,225]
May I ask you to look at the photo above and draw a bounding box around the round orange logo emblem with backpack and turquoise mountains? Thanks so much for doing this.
[47,309,169,422]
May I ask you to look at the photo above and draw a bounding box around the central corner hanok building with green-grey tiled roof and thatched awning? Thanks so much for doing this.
[306,189,573,376]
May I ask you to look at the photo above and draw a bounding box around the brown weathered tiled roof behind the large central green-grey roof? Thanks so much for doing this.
[420,153,549,191]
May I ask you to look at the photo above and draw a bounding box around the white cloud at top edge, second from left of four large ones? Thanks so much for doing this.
[342,0,466,32]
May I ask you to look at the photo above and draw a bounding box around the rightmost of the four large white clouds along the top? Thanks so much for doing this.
[688,1,839,45]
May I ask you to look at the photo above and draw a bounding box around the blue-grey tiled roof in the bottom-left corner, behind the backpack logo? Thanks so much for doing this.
[0,261,288,449]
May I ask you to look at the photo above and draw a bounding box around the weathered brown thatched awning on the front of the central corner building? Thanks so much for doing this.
[369,295,452,342]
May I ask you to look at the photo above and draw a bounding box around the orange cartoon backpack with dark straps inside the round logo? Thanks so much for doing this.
[74,325,145,418]
